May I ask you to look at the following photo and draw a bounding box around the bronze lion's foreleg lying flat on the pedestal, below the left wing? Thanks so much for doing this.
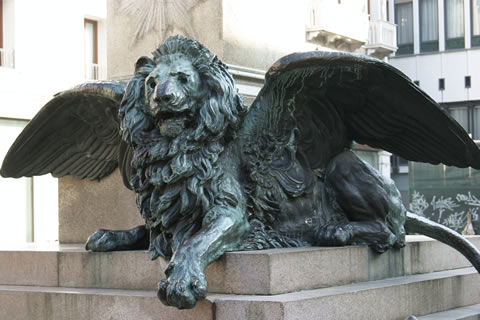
[85,225,150,252]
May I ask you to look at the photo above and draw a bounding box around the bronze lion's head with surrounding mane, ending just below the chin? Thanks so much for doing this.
[120,36,245,144]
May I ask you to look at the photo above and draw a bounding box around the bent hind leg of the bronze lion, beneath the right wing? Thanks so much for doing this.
[316,151,406,252]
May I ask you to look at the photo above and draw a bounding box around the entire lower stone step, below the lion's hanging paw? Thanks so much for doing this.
[0,268,480,320]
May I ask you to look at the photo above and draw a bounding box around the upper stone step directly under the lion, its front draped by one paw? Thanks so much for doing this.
[0,236,480,295]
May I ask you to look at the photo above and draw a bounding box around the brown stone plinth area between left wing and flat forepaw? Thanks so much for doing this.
[58,169,145,243]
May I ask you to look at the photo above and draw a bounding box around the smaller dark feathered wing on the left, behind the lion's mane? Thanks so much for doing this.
[0,81,133,186]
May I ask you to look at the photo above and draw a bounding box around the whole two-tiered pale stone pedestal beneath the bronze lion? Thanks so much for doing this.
[0,236,480,320]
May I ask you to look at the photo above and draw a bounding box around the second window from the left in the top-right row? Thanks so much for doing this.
[419,0,438,52]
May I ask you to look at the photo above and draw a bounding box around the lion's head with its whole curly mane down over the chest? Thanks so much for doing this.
[119,36,246,257]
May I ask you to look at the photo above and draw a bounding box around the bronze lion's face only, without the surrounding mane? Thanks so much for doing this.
[145,55,206,137]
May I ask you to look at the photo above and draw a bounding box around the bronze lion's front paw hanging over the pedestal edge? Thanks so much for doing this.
[157,257,207,309]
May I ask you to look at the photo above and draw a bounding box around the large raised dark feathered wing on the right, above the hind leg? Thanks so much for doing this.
[242,51,480,169]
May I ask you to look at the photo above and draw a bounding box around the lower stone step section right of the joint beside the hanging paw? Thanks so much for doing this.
[211,268,480,320]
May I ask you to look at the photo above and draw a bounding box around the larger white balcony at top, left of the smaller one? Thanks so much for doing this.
[306,0,368,51]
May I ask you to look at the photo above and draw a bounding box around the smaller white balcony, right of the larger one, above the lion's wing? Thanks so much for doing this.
[365,20,398,59]
